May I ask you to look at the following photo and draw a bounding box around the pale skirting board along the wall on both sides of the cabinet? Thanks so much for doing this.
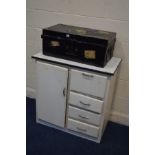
[26,87,129,126]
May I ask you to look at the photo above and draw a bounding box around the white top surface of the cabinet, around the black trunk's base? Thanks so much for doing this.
[33,52,121,74]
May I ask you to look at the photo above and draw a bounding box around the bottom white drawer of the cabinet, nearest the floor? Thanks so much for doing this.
[67,118,99,137]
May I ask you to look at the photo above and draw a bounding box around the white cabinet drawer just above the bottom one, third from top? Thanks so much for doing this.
[68,106,101,125]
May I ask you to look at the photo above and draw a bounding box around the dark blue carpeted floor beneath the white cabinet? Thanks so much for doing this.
[26,98,129,155]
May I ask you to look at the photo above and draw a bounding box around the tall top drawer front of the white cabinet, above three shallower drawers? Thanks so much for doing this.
[70,70,107,98]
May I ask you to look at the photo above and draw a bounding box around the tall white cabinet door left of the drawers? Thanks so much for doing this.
[37,62,68,127]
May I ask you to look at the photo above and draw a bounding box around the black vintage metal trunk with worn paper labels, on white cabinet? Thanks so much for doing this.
[41,24,116,67]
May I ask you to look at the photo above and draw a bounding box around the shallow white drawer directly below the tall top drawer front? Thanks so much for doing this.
[68,92,103,113]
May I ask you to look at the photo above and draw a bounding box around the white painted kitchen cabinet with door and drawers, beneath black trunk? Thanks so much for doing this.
[33,53,121,142]
